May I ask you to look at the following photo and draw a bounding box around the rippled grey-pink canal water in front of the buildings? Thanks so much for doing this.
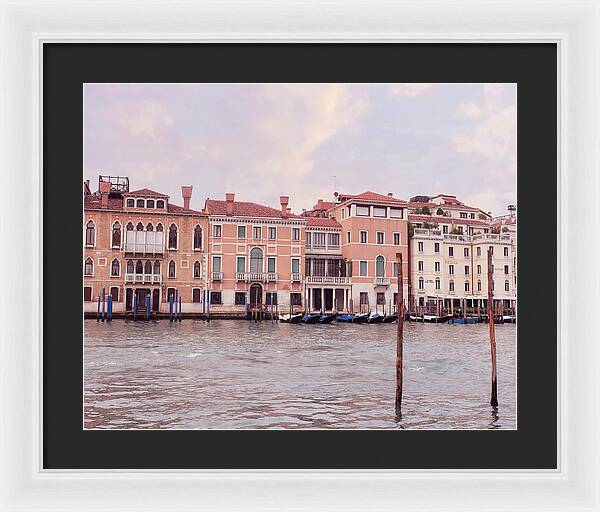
[84,320,516,429]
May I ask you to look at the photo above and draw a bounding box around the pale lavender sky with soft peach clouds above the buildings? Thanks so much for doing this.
[84,83,517,215]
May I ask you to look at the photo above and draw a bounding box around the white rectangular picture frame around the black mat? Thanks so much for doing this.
[0,0,600,512]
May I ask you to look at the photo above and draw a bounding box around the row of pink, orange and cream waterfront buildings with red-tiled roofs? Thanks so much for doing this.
[83,176,517,315]
